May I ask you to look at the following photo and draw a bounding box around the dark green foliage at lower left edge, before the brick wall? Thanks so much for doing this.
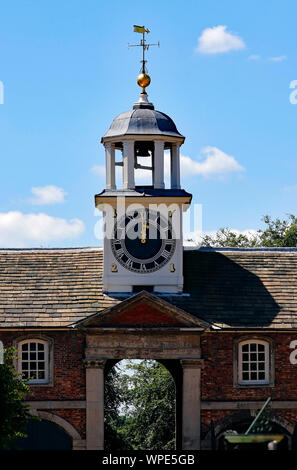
[0,348,32,449]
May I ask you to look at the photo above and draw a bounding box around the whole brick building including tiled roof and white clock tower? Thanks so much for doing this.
[0,50,297,450]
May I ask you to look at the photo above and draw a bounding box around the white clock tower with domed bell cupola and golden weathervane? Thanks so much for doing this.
[95,27,192,293]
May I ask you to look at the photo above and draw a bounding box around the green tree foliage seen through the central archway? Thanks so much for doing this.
[106,360,175,450]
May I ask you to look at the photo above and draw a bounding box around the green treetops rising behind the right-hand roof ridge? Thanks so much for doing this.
[199,214,297,248]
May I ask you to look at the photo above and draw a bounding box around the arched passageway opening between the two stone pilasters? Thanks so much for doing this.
[104,360,182,450]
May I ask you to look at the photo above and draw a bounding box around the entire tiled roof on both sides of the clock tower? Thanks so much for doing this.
[0,248,297,329]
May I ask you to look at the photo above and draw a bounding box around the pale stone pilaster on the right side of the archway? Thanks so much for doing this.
[181,359,203,450]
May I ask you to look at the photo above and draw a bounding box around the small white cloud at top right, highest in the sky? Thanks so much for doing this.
[196,25,246,54]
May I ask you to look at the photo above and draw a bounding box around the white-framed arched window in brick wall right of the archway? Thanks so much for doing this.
[238,339,270,385]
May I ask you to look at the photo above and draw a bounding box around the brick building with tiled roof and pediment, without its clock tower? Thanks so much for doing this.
[0,248,297,449]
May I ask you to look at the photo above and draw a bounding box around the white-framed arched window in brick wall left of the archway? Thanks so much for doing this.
[18,339,49,384]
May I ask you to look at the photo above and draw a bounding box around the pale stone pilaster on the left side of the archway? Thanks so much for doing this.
[85,360,105,450]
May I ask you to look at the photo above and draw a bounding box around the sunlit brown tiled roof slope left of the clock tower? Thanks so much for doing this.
[0,248,115,327]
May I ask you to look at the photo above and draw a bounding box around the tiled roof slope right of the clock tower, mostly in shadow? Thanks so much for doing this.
[171,249,297,328]
